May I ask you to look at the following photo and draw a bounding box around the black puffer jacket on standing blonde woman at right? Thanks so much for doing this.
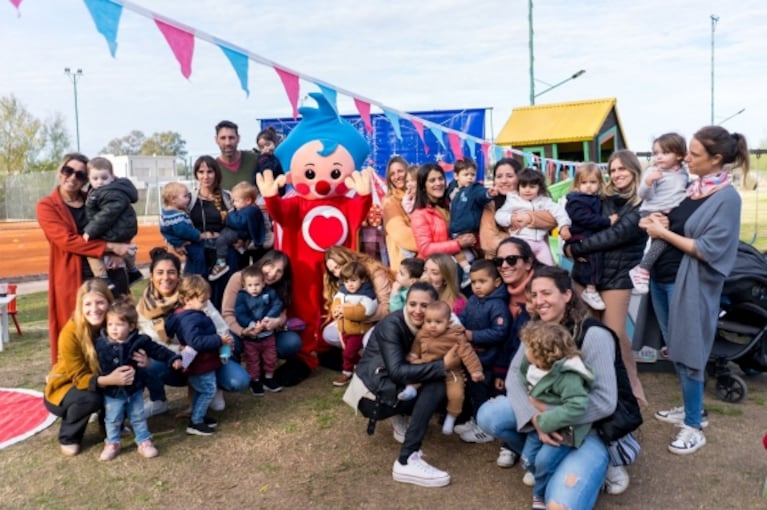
[570,195,647,290]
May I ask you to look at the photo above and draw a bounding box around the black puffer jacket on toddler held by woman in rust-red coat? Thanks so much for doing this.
[85,177,138,243]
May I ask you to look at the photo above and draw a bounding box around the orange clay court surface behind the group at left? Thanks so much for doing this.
[0,222,165,279]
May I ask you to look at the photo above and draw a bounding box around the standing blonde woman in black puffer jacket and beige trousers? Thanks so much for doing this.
[567,150,647,404]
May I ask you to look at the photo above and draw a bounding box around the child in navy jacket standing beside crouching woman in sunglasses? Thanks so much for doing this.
[455,259,511,443]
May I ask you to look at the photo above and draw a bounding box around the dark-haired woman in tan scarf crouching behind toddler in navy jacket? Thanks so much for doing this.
[136,248,250,418]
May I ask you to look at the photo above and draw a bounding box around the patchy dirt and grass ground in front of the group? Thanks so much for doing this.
[0,326,767,510]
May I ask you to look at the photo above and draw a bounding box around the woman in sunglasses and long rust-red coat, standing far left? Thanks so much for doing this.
[37,153,136,363]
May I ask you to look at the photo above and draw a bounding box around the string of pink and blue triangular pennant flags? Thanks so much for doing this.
[10,0,604,175]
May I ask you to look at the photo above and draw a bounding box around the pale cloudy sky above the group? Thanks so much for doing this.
[0,0,767,163]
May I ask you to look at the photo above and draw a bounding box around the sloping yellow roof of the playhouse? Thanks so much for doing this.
[495,97,616,147]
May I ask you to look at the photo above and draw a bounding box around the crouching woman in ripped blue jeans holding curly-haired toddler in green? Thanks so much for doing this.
[477,267,618,508]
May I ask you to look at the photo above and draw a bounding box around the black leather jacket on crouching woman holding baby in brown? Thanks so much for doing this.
[356,310,445,407]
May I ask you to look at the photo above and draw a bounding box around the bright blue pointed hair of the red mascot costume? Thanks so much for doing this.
[274,92,370,170]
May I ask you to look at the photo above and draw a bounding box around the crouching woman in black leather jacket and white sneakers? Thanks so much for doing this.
[356,282,460,487]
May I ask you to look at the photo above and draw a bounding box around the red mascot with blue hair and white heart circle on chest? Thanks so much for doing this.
[257,93,372,386]
